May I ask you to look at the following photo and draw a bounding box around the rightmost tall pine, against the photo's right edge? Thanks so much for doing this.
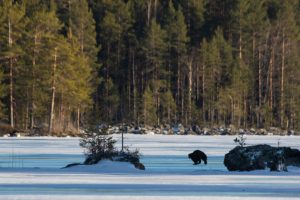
[275,1,300,129]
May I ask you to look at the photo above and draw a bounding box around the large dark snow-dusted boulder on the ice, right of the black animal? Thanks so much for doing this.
[224,144,300,171]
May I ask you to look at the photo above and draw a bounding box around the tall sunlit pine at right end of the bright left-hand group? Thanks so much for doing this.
[58,0,99,131]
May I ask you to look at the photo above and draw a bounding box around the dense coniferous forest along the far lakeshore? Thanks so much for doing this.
[0,0,300,132]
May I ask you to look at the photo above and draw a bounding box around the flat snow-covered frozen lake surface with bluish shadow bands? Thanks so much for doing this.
[0,135,300,200]
